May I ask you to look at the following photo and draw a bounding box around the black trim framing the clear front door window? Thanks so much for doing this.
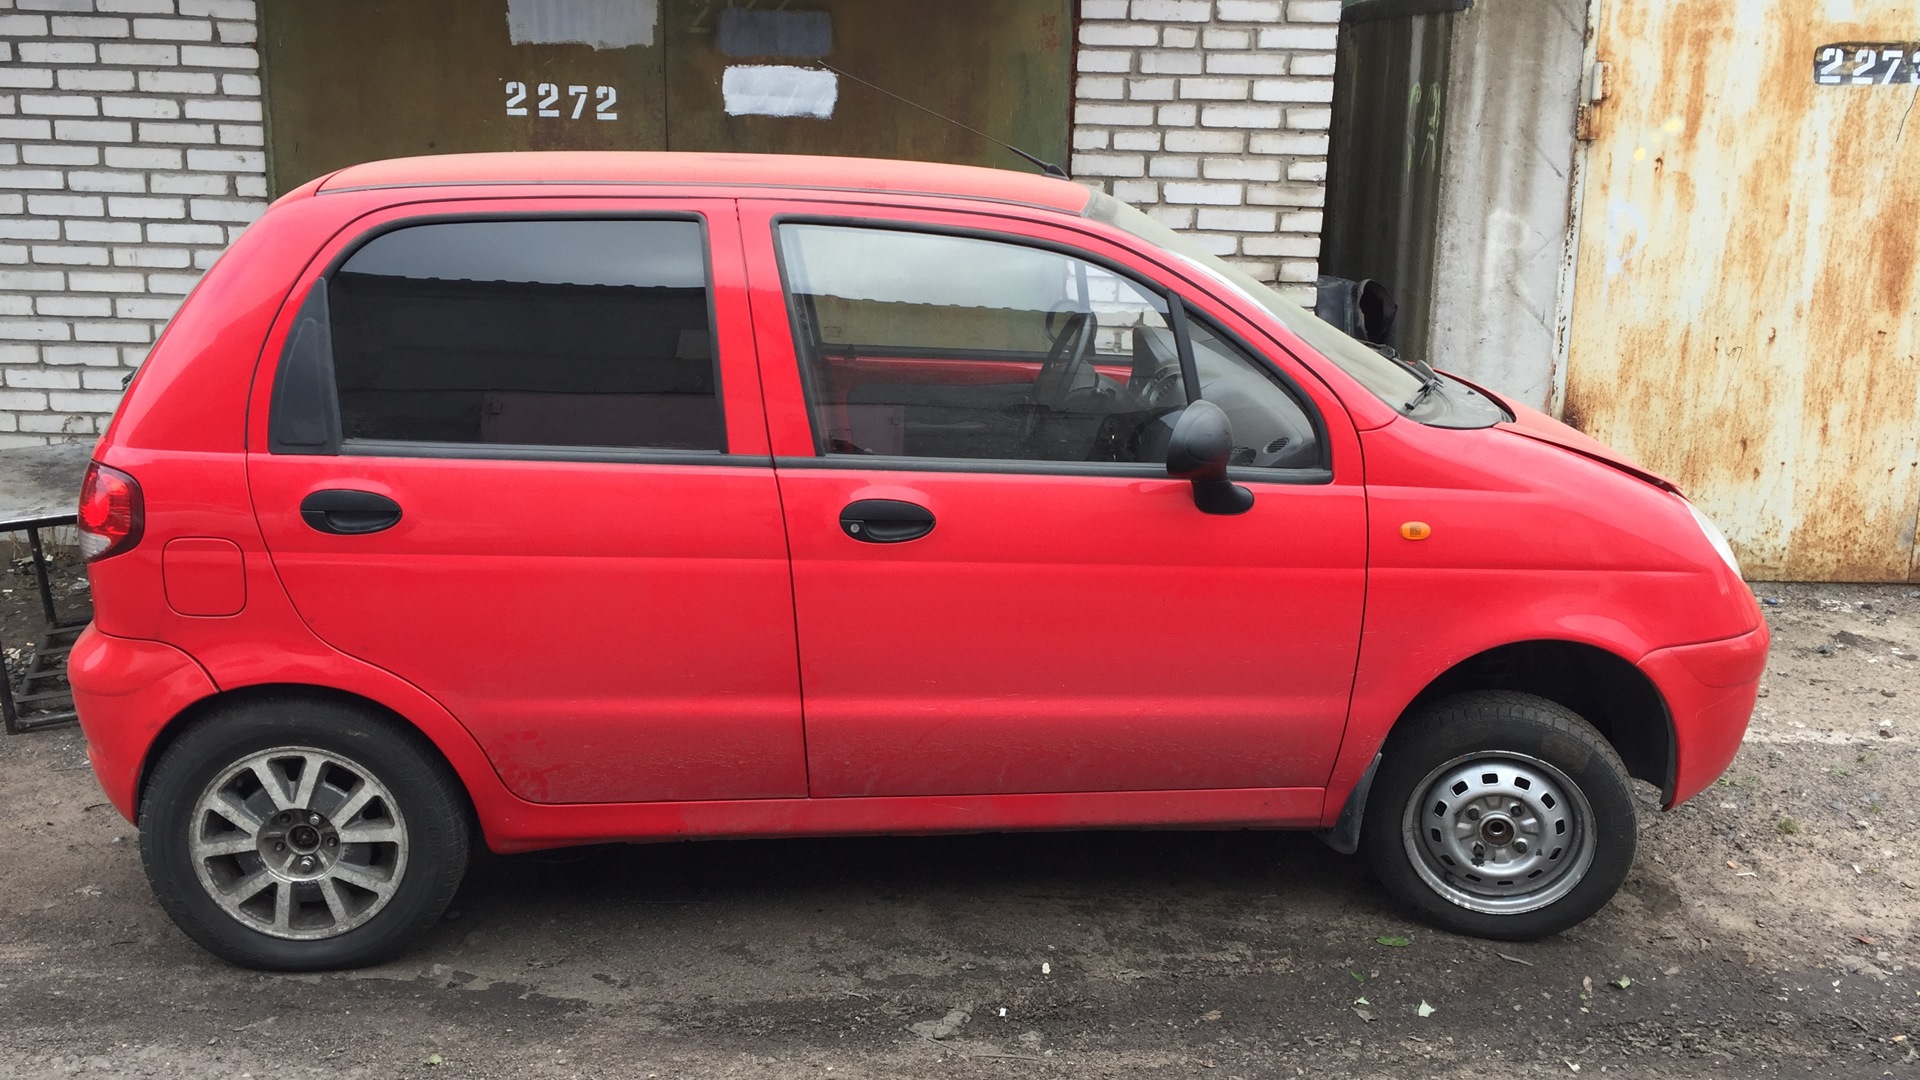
[768,211,1332,474]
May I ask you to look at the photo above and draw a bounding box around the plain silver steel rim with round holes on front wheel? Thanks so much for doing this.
[1400,751,1594,915]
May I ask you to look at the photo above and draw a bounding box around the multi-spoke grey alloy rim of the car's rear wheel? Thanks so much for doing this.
[186,746,407,942]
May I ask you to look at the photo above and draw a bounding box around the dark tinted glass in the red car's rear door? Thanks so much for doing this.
[328,221,726,450]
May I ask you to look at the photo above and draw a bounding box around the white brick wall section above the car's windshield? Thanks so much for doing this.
[1069,0,1340,300]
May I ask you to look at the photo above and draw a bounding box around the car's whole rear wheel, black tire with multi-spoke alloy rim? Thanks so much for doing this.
[140,698,468,970]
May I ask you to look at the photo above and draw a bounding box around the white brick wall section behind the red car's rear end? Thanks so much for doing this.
[0,0,267,446]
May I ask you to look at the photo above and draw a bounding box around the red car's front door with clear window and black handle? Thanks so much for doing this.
[741,202,1365,798]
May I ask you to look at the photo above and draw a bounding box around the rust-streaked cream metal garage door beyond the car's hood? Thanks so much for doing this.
[1563,0,1920,580]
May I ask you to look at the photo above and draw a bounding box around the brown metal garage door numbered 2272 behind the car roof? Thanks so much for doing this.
[259,0,1073,194]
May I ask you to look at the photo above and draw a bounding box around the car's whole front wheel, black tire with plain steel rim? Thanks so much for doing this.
[1359,690,1638,942]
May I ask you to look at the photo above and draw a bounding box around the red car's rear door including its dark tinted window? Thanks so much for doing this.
[248,198,806,803]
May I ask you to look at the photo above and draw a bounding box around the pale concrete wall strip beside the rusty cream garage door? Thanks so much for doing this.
[1427,0,1588,409]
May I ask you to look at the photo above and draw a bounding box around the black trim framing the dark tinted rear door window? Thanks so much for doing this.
[267,209,737,457]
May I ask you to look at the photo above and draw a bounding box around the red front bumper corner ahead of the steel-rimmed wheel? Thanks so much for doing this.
[1640,623,1770,809]
